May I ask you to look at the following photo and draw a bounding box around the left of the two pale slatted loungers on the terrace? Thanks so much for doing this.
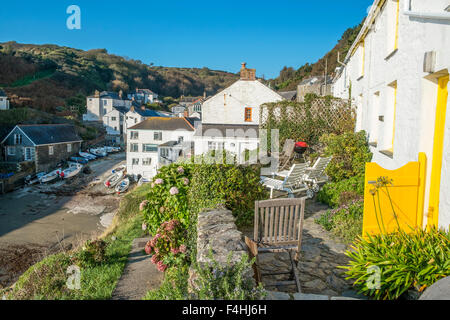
[261,163,308,199]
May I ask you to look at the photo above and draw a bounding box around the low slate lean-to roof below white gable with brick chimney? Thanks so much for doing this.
[195,123,259,138]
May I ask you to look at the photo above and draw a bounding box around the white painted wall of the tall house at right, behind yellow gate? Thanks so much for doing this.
[333,0,450,228]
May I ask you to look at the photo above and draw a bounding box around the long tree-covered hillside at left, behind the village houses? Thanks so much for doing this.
[0,42,238,113]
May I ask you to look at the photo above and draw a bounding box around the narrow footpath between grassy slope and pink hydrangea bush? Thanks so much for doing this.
[111,238,163,300]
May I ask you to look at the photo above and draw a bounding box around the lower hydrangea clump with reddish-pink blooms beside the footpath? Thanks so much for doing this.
[145,220,189,272]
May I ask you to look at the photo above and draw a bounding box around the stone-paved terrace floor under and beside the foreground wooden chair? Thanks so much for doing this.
[244,200,358,297]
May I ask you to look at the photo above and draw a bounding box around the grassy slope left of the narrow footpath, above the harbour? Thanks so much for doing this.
[0,184,150,300]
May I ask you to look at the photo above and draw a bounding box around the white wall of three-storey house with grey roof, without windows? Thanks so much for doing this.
[127,129,194,178]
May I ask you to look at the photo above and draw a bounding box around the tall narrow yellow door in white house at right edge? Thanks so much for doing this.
[427,75,449,228]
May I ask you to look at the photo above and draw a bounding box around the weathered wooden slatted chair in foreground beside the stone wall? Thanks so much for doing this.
[245,198,306,292]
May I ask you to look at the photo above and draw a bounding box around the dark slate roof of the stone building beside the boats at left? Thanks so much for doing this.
[17,124,82,145]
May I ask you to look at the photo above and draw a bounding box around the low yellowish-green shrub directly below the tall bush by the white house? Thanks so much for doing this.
[317,175,364,208]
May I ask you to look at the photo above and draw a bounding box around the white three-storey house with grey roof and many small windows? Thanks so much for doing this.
[127,117,194,178]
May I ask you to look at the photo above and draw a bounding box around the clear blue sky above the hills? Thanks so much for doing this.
[0,0,373,78]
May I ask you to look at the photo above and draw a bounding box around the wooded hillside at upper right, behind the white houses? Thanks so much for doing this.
[268,20,364,91]
